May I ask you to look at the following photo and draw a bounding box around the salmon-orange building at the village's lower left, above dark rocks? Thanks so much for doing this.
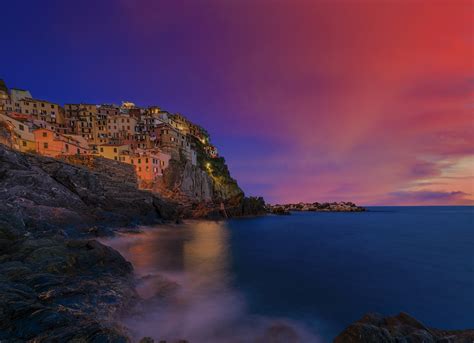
[33,128,89,157]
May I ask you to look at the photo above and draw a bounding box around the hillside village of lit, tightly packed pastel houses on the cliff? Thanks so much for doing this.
[0,79,218,188]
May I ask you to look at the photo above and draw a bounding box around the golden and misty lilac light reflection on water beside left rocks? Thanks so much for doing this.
[104,221,318,343]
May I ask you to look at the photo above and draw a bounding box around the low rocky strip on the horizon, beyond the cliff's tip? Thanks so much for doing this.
[267,201,366,215]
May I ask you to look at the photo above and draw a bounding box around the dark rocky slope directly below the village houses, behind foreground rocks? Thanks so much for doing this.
[0,145,175,236]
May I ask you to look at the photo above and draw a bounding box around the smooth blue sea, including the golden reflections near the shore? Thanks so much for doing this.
[107,207,474,342]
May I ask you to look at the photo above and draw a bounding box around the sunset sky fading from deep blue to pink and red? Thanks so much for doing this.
[0,0,474,205]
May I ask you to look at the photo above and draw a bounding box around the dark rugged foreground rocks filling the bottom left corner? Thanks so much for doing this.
[0,230,137,342]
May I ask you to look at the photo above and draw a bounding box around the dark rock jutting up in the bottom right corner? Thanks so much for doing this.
[334,312,474,343]
